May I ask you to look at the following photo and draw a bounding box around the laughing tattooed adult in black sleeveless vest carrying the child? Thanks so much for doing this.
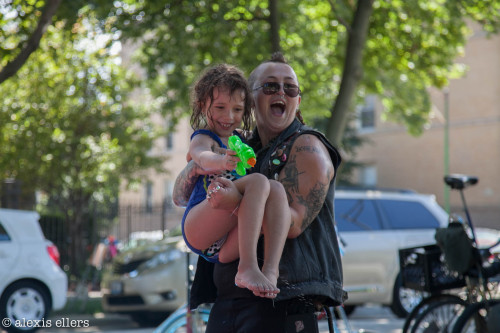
[174,53,347,333]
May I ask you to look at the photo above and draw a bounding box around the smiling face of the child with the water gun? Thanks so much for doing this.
[203,88,245,137]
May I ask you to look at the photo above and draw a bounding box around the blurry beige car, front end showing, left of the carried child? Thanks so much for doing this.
[102,236,193,326]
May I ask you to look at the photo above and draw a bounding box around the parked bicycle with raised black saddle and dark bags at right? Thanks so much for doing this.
[400,175,500,333]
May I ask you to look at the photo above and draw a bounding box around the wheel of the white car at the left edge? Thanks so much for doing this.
[0,281,51,333]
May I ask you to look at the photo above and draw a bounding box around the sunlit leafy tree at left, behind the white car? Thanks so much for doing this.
[0,13,162,273]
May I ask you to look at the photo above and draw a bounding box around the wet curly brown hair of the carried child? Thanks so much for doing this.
[191,64,253,131]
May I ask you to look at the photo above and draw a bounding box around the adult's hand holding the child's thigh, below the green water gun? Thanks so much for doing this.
[207,177,243,212]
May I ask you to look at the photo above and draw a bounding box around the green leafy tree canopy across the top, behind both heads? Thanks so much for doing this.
[0,0,500,145]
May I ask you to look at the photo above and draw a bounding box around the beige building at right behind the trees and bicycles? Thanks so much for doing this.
[352,25,500,228]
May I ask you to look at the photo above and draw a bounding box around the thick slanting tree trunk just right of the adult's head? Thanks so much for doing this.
[326,0,373,147]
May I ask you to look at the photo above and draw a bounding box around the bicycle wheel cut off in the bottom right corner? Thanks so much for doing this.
[452,300,500,333]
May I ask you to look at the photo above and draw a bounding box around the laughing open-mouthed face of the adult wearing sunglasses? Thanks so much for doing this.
[252,63,300,141]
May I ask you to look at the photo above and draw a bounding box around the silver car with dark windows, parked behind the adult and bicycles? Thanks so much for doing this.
[335,189,500,317]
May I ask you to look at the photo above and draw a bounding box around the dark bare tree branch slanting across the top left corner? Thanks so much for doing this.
[0,0,61,84]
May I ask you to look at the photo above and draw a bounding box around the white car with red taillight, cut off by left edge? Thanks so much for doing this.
[0,209,68,332]
